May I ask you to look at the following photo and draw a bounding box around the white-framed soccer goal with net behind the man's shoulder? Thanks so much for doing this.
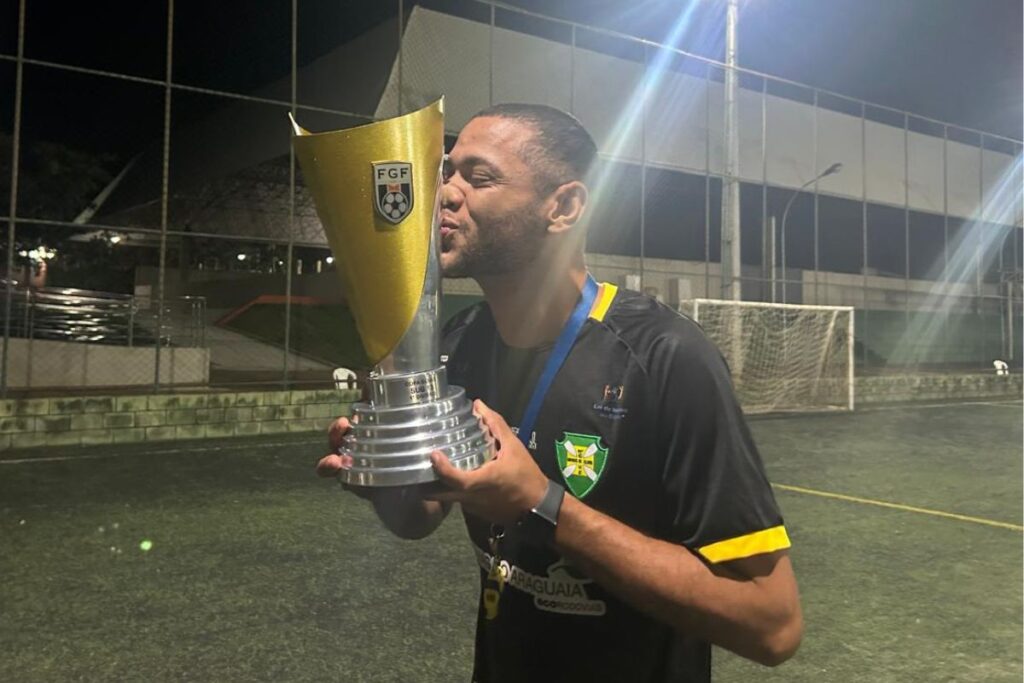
[682,299,854,413]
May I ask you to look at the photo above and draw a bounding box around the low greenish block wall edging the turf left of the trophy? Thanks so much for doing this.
[0,390,359,451]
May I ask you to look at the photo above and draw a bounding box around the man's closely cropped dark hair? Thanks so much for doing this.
[473,102,597,189]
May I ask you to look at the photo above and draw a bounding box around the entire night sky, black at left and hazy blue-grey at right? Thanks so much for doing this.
[0,0,1024,156]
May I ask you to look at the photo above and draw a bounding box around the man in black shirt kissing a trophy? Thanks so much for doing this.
[317,104,803,683]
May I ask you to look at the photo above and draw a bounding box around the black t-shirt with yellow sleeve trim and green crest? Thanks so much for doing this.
[442,284,790,683]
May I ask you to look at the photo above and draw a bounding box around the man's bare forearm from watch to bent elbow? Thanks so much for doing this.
[555,496,802,665]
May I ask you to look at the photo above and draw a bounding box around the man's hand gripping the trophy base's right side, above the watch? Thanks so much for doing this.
[427,400,548,524]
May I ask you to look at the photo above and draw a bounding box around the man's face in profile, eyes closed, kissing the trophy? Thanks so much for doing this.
[440,117,547,278]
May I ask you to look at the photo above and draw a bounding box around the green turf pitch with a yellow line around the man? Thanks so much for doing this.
[0,402,1024,683]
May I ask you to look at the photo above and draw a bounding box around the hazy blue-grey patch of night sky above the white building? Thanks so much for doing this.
[524,0,1024,139]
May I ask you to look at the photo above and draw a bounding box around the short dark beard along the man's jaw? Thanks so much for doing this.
[443,218,541,279]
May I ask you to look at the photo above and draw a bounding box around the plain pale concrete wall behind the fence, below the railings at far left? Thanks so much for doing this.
[7,338,210,389]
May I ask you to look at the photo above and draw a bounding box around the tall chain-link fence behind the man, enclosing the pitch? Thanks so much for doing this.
[0,0,1024,394]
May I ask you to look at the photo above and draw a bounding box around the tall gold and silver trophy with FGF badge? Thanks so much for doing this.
[292,99,494,486]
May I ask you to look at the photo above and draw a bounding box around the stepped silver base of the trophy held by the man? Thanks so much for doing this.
[338,368,494,486]
